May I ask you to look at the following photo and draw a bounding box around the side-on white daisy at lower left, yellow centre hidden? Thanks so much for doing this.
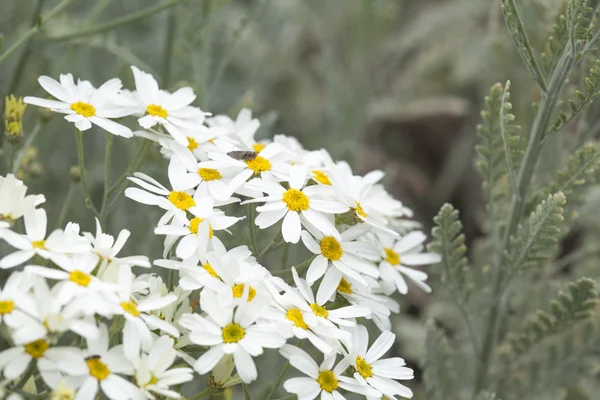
[13,278,98,344]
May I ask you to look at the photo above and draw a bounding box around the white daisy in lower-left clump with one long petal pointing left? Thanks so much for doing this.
[25,253,118,316]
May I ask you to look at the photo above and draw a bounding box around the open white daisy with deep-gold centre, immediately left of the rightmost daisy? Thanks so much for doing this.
[302,224,379,303]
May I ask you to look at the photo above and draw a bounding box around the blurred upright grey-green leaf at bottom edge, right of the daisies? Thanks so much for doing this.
[423,320,457,400]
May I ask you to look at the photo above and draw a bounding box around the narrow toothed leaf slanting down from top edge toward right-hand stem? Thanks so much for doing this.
[502,0,546,92]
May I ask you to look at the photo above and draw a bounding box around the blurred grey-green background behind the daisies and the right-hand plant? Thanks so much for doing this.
[0,0,592,399]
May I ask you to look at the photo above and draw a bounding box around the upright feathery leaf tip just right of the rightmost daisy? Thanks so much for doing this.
[428,204,471,301]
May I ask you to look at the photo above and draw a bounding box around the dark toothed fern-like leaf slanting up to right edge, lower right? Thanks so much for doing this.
[509,278,597,357]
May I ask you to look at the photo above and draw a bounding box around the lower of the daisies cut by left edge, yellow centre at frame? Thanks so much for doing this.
[0,272,36,329]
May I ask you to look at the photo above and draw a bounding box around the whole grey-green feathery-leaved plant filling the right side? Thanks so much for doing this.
[424,0,600,400]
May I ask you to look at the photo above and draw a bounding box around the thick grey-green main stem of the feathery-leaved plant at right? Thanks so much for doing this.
[473,44,577,397]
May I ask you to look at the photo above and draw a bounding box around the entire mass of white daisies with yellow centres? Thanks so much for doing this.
[0,67,439,399]
